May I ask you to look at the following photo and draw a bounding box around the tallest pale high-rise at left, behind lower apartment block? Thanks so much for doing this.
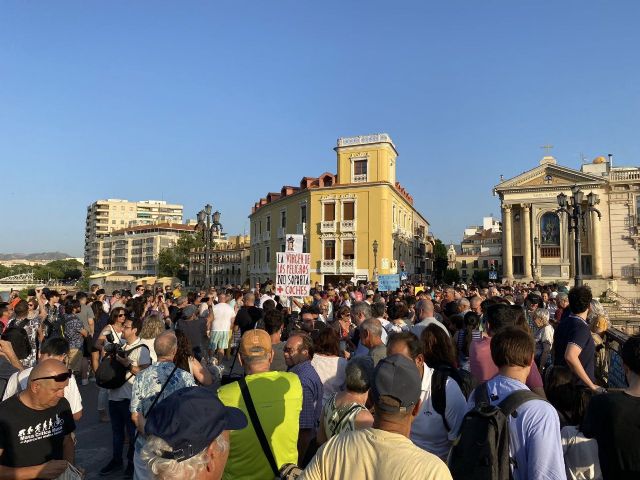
[84,198,183,270]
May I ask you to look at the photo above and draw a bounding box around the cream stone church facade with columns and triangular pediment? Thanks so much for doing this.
[494,156,640,299]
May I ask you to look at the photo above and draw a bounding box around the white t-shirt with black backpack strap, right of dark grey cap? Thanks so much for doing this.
[409,365,467,458]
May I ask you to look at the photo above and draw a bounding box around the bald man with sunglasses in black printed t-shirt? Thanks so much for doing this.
[0,359,76,479]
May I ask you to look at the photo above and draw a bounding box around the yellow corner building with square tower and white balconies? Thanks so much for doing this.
[249,133,433,284]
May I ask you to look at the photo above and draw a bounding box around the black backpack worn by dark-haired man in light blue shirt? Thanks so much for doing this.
[447,383,543,480]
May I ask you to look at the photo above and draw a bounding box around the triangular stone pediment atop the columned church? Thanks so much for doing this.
[495,164,606,192]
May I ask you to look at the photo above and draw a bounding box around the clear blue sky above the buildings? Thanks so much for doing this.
[0,0,640,255]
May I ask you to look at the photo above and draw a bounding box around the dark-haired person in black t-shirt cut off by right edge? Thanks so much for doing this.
[581,335,640,480]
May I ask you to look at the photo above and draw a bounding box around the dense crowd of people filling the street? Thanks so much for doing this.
[0,282,640,480]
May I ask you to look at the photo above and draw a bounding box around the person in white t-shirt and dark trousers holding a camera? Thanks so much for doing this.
[100,318,151,478]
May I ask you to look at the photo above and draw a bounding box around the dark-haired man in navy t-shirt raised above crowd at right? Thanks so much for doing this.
[553,285,602,391]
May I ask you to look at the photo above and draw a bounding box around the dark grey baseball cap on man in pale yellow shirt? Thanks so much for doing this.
[371,354,422,412]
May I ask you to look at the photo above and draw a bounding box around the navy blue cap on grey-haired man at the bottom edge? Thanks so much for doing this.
[144,387,247,462]
